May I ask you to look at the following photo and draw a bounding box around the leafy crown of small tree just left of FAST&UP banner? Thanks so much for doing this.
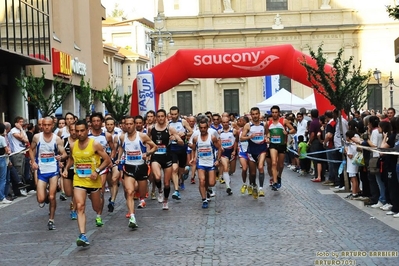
[97,87,132,121]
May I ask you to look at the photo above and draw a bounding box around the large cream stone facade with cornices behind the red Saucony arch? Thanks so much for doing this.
[159,0,399,113]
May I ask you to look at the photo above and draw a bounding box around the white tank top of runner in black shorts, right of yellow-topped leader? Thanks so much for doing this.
[123,131,145,165]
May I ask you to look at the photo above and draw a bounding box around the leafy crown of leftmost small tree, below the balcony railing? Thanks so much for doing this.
[15,68,72,117]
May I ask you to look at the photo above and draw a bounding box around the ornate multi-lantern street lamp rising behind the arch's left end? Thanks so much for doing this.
[147,12,175,109]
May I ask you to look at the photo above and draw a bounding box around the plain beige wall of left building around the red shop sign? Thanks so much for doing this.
[33,0,109,116]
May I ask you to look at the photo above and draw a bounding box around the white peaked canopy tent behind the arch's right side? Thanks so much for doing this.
[256,89,313,112]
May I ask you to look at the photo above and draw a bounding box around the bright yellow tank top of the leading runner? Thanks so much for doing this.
[72,138,102,188]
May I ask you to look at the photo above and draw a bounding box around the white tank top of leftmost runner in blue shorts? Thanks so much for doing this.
[36,132,59,174]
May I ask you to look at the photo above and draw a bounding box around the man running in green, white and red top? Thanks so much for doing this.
[266,105,296,191]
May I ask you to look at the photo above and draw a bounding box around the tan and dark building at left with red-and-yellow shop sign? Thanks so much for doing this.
[0,0,109,121]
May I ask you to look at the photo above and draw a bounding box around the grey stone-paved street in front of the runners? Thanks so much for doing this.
[0,168,399,266]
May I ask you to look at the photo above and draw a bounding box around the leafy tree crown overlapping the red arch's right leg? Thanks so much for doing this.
[301,45,371,117]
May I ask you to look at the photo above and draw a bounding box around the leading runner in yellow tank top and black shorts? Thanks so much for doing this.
[62,120,111,246]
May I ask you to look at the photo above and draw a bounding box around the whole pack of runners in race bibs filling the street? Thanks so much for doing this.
[30,106,295,246]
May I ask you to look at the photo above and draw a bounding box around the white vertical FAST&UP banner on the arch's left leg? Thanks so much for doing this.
[137,71,156,117]
